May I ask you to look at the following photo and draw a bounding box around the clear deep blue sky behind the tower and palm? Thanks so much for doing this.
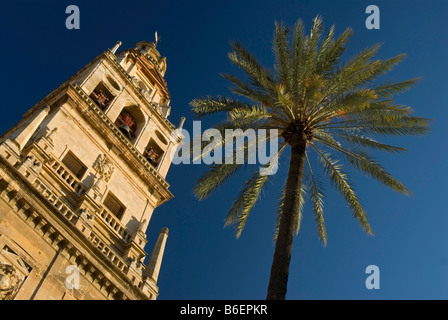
[0,0,448,300]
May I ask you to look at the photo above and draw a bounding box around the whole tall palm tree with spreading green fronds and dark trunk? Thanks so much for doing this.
[190,16,429,299]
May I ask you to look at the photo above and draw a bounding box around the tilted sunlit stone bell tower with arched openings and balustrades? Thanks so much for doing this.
[0,41,184,300]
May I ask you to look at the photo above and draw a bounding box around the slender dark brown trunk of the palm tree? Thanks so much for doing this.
[266,131,306,300]
